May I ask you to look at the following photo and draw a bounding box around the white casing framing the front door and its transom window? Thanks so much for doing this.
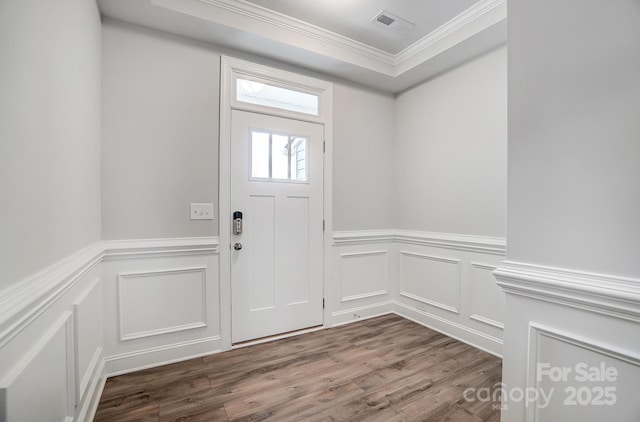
[218,56,333,350]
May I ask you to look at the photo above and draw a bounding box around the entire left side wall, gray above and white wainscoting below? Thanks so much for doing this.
[0,0,103,422]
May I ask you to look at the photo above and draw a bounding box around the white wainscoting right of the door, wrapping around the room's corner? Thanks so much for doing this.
[326,230,505,356]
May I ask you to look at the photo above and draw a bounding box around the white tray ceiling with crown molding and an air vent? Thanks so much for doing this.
[98,0,506,93]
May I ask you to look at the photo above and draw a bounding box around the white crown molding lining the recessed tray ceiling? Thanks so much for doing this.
[151,0,507,78]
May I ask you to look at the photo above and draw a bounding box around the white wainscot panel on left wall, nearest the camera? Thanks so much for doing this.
[0,312,75,422]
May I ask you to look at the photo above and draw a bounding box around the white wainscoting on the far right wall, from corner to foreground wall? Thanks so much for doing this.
[395,231,505,356]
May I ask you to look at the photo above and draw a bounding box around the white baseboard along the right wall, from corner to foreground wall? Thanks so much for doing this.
[393,301,503,358]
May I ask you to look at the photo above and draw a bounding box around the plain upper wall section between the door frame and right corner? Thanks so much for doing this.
[333,83,395,230]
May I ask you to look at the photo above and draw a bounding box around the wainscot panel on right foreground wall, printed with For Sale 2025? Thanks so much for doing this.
[527,324,640,422]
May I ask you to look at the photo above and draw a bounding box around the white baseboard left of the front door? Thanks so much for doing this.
[105,335,222,377]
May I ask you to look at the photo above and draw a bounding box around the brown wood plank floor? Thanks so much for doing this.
[94,315,502,422]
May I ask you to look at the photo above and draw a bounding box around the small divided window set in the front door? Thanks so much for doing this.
[249,129,309,182]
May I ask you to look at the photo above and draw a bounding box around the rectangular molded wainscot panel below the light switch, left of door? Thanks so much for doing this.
[118,267,207,341]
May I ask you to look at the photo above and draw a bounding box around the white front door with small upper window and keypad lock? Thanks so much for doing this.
[231,110,324,343]
